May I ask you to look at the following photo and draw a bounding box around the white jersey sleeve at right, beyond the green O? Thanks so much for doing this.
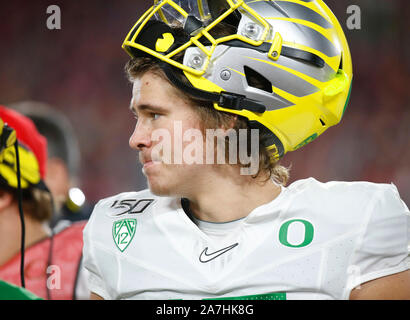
[348,184,410,290]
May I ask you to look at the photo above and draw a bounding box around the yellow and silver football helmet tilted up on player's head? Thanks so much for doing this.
[122,0,353,158]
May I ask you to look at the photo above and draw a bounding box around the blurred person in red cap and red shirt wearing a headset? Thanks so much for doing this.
[0,106,88,300]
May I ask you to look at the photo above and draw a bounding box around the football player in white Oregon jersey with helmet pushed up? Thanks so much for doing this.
[84,0,410,300]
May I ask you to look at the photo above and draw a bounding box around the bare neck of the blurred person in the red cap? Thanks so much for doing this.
[0,212,49,266]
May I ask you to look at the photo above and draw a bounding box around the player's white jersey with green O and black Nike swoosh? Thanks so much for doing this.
[83,178,410,300]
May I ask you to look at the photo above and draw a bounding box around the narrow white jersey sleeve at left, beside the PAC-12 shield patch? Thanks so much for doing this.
[83,204,111,300]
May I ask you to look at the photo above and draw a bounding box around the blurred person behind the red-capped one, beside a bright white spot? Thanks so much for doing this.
[8,101,93,228]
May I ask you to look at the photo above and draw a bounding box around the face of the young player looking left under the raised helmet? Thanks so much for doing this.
[129,72,207,196]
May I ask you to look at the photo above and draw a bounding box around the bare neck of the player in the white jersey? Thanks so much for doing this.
[186,169,281,222]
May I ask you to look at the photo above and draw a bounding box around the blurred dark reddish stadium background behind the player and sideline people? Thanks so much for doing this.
[0,0,410,205]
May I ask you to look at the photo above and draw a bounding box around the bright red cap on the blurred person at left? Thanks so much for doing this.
[0,105,47,180]
